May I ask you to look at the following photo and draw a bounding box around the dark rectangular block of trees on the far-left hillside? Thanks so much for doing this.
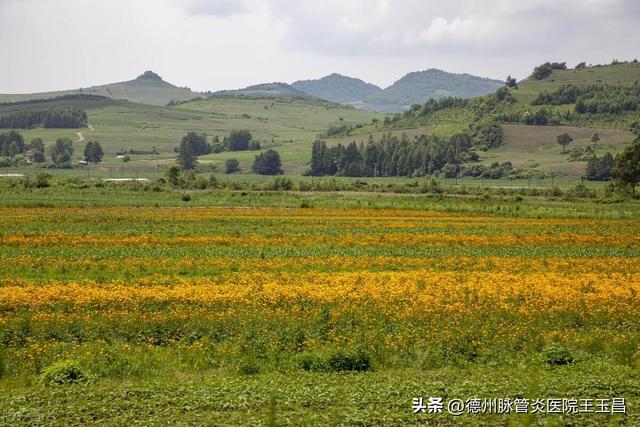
[0,106,87,129]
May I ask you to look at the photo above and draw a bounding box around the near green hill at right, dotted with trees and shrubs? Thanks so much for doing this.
[344,63,640,180]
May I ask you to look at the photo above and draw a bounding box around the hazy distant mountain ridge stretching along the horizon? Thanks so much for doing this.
[0,68,504,113]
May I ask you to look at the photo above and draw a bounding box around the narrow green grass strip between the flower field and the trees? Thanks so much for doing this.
[0,182,640,219]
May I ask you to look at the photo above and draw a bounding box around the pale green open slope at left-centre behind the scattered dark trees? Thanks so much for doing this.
[0,98,379,174]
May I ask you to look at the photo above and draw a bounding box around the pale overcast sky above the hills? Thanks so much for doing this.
[0,0,640,93]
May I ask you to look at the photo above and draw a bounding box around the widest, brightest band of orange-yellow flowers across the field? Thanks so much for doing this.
[0,271,640,317]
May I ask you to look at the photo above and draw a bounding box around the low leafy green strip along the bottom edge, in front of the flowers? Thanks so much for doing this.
[0,362,640,426]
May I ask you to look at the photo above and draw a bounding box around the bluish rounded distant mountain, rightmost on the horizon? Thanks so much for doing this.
[360,68,504,112]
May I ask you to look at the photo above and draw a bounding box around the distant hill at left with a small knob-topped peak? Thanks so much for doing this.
[0,71,202,105]
